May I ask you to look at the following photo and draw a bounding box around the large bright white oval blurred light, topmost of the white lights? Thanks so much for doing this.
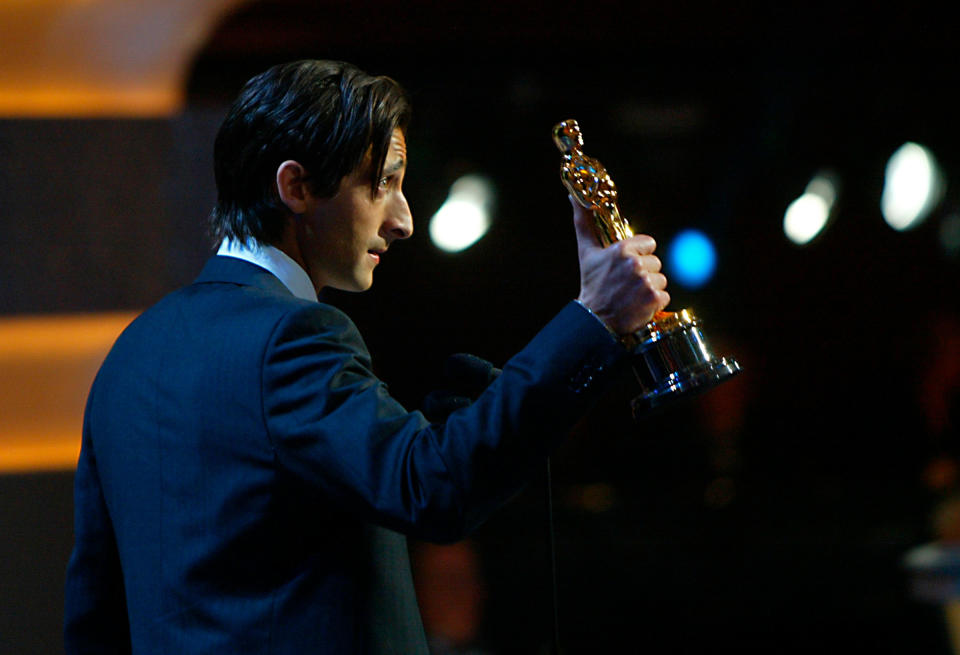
[880,142,944,231]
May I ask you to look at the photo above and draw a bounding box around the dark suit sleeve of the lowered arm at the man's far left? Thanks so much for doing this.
[64,393,131,655]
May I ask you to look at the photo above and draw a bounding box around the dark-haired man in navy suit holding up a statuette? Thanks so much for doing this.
[66,61,668,655]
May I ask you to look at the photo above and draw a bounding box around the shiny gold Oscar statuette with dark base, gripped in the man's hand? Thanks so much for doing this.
[553,120,740,418]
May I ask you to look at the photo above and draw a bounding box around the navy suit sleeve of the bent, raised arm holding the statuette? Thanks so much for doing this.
[262,303,625,542]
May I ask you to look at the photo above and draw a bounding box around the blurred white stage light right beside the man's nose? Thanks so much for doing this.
[429,175,495,252]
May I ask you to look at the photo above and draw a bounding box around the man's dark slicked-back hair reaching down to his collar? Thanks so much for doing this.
[210,60,410,243]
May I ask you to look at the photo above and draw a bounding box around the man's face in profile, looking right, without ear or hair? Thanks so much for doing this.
[296,129,413,291]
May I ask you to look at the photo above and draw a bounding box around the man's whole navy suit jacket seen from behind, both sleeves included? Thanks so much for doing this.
[66,257,624,655]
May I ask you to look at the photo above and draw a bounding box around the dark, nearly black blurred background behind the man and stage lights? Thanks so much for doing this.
[0,0,960,653]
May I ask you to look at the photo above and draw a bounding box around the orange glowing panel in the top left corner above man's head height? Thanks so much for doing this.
[0,0,245,118]
